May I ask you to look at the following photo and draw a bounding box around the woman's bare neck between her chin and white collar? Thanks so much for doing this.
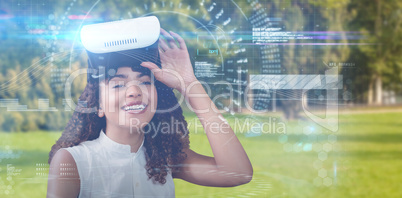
[105,124,144,153]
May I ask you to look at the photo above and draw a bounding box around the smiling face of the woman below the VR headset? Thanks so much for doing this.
[99,67,157,131]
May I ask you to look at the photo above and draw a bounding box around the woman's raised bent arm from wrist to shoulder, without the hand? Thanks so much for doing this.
[175,81,253,186]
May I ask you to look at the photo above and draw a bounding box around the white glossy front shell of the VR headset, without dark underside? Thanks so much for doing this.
[80,16,160,54]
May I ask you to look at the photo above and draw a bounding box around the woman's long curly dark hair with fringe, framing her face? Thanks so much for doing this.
[48,46,189,184]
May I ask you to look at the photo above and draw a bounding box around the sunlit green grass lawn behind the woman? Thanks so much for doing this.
[0,110,402,197]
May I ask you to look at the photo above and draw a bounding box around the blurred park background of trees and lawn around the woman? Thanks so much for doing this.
[0,0,402,197]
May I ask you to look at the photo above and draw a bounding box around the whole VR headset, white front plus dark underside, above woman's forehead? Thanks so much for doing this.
[81,16,160,82]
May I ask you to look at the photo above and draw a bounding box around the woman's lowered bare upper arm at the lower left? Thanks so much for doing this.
[46,149,80,198]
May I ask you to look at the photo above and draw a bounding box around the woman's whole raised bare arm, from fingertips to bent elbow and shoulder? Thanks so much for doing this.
[141,29,253,186]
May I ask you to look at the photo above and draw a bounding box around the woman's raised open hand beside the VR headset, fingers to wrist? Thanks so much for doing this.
[141,28,197,93]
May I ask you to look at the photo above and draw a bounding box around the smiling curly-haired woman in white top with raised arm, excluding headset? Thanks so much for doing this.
[48,29,253,197]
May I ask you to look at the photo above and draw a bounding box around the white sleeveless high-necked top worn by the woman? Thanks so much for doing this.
[64,131,175,198]
